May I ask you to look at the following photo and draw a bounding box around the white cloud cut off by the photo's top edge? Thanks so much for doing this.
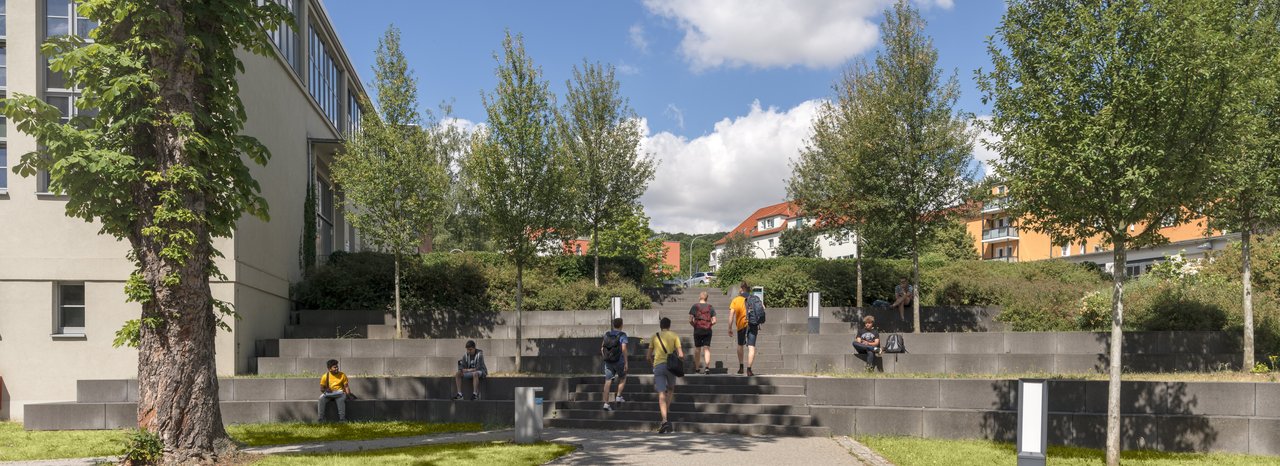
[631,0,954,70]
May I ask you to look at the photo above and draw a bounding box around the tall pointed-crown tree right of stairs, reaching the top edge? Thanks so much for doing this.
[819,0,977,332]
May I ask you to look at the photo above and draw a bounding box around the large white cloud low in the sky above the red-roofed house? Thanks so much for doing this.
[640,100,819,233]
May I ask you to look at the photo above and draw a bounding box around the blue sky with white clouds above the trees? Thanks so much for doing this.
[325,0,1004,233]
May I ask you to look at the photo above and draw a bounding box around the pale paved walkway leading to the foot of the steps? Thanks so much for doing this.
[0,429,892,466]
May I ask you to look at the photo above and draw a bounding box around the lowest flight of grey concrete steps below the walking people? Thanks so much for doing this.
[548,375,831,437]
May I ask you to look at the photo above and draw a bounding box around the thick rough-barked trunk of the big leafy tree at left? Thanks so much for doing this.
[129,0,234,463]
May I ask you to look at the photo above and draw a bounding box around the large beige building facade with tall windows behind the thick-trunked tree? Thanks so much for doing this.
[0,0,366,420]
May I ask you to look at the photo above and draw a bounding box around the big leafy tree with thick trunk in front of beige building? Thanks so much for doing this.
[4,0,289,463]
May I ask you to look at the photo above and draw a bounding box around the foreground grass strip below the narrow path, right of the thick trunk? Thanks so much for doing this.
[253,442,573,466]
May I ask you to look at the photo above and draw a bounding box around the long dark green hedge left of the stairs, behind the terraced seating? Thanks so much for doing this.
[293,252,650,312]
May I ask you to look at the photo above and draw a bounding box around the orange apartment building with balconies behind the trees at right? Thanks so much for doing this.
[965,186,1239,277]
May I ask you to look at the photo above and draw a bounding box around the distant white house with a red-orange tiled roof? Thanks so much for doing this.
[708,202,858,270]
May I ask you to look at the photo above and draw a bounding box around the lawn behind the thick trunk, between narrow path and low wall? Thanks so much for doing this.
[0,421,481,461]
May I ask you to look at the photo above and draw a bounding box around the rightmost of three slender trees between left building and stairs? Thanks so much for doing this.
[556,63,655,287]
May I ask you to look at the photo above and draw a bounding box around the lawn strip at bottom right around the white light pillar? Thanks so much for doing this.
[858,437,1280,466]
